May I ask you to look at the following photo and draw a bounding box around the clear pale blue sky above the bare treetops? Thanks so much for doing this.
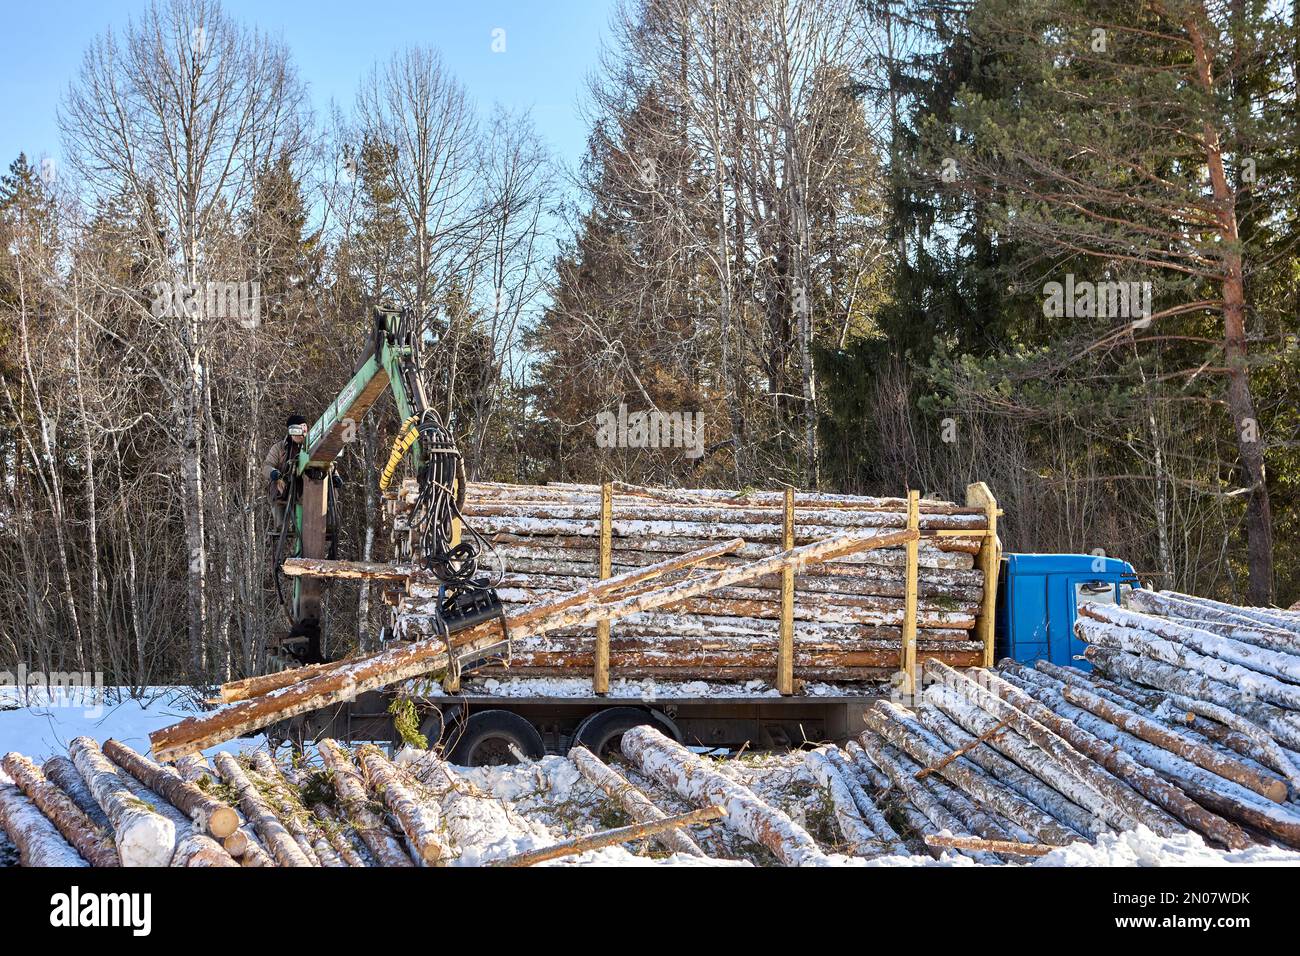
[0,0,614,175]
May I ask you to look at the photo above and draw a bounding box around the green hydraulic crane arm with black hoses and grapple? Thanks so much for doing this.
[276,310,501,662]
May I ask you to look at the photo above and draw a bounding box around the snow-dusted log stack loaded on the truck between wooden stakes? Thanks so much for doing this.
[389,483,998,695]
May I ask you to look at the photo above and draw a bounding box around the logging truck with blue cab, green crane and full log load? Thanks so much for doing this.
[258,310,1138,766]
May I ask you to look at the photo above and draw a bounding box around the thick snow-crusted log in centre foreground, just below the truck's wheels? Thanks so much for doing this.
[623,726,827,866]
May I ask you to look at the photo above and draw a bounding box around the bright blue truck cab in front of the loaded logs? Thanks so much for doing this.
[993,554,1141,670]
